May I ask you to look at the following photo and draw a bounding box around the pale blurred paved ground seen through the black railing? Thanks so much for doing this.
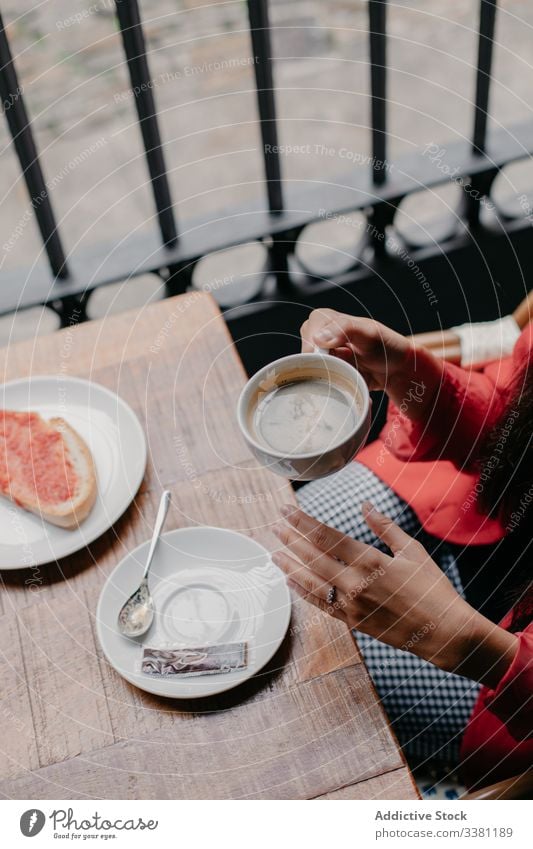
[0,0,533,340]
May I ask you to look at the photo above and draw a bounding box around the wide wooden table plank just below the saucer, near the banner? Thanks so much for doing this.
[0,664,403,799]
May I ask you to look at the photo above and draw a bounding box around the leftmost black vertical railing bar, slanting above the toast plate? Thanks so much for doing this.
[0,14,68,278]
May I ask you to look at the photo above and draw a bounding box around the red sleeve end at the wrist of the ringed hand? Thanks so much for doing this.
[483,628,533,740]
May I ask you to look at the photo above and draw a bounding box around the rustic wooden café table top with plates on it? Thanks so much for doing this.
[0,293,418,799]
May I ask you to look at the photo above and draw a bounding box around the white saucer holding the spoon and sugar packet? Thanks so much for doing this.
[96,527,291,699]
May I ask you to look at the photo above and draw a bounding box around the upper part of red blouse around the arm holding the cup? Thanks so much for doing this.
[357,324,533,545]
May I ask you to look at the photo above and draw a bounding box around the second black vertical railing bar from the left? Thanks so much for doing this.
[115,0,178,247]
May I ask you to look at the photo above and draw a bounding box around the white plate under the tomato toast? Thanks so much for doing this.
[0,375,146,569]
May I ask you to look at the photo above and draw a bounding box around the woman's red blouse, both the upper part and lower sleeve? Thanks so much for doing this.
[357,324,533,786]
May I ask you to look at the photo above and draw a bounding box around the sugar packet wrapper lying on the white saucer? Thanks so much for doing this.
[141,643,248,678]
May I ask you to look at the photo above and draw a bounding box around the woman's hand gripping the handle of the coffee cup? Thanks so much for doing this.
[300,309,442,419]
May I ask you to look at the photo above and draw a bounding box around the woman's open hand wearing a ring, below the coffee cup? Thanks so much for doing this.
[273,504,517,686]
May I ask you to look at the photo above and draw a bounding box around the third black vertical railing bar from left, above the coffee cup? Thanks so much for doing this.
[248,0,283,215]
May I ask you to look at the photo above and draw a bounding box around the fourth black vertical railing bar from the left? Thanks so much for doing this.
[368,0,387,185]
